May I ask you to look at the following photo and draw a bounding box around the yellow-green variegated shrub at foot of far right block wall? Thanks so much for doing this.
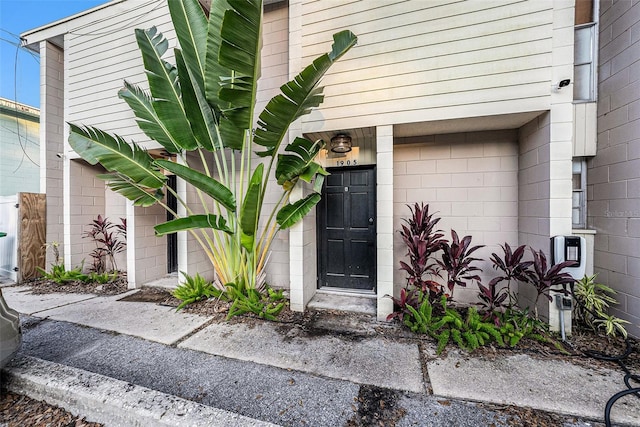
[573,274,629,338]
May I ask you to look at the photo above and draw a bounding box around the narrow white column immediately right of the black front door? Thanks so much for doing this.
[376,125,394,320]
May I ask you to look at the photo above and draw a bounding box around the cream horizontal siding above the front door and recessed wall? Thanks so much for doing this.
[302,0,556,131]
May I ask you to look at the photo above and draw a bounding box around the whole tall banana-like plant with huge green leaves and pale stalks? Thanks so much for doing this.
[69,0,356,298]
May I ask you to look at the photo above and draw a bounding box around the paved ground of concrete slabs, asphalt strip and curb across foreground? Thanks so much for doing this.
[2,286,640,426]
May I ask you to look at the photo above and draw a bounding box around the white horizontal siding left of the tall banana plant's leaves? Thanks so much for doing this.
[65,0,176,141]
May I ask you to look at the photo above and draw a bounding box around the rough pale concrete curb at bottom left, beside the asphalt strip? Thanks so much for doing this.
[2,356,276,427]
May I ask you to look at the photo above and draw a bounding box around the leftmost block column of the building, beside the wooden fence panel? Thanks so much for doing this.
[40,40,65,266]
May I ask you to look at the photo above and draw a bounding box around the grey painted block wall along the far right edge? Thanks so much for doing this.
[587,0,640,336]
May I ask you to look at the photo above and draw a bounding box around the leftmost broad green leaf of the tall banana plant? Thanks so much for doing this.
[69,123,166,189]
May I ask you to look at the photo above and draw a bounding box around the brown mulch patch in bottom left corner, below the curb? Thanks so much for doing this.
[0,393,102,427]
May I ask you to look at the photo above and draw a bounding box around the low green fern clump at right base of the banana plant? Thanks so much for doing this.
[227,283,287,320]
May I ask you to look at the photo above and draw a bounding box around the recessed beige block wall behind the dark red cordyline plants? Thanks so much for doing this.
[393,131,518,302]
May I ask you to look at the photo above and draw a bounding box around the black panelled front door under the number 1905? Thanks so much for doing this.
[318,167,376,291]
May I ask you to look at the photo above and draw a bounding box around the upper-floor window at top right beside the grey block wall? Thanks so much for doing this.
[573,0,598,102]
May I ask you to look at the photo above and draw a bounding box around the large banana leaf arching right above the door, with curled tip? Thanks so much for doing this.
[254,30,357,156]
